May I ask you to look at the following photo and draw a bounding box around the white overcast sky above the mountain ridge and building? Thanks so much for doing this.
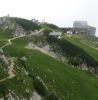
[0,0,98,36]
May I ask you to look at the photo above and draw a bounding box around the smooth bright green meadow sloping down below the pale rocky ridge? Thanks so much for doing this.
[4,41,98,100]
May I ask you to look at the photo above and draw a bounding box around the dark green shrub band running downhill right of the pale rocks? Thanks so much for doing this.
[47,36,98,72]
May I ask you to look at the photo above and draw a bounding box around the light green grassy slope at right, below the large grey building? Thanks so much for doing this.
[64,35,98,60]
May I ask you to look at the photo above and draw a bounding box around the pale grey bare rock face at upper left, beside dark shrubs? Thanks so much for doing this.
[0,16,26,37]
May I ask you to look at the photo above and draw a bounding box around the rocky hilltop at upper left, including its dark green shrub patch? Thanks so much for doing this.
[0,15,43,37]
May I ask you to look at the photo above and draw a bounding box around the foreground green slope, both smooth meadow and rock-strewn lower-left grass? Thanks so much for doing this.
[0,32,98,100]
